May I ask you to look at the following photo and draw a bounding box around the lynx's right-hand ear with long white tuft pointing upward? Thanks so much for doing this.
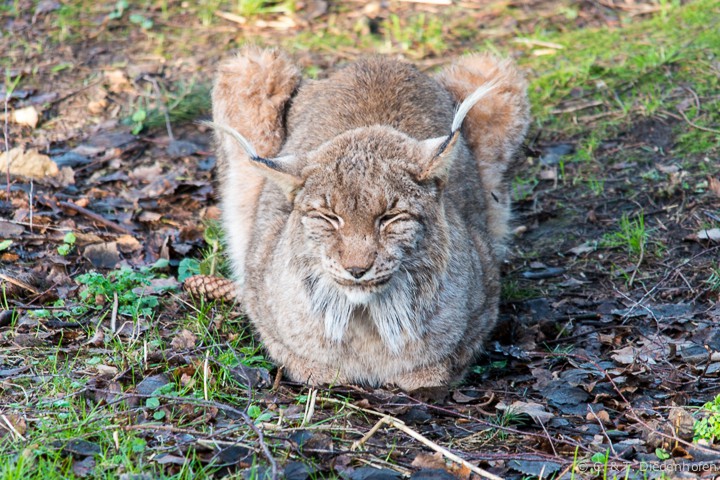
[418,80,498,181]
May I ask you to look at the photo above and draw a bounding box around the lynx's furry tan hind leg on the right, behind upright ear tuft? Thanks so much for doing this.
[437,54,530,253]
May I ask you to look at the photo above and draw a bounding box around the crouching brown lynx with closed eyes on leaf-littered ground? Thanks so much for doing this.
[210,47,529,390]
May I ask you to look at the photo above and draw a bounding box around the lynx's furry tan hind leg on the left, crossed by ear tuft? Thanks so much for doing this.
[212,46,300,286]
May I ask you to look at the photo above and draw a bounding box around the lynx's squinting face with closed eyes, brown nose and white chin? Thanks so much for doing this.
[295,131,440,304]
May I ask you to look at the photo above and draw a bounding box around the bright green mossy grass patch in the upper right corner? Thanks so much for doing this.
[519,0,720,152]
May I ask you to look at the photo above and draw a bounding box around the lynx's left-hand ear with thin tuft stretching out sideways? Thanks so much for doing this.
[200,121,303,202]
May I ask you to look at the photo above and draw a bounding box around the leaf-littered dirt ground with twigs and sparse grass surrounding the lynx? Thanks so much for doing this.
[0,0,720,480]
